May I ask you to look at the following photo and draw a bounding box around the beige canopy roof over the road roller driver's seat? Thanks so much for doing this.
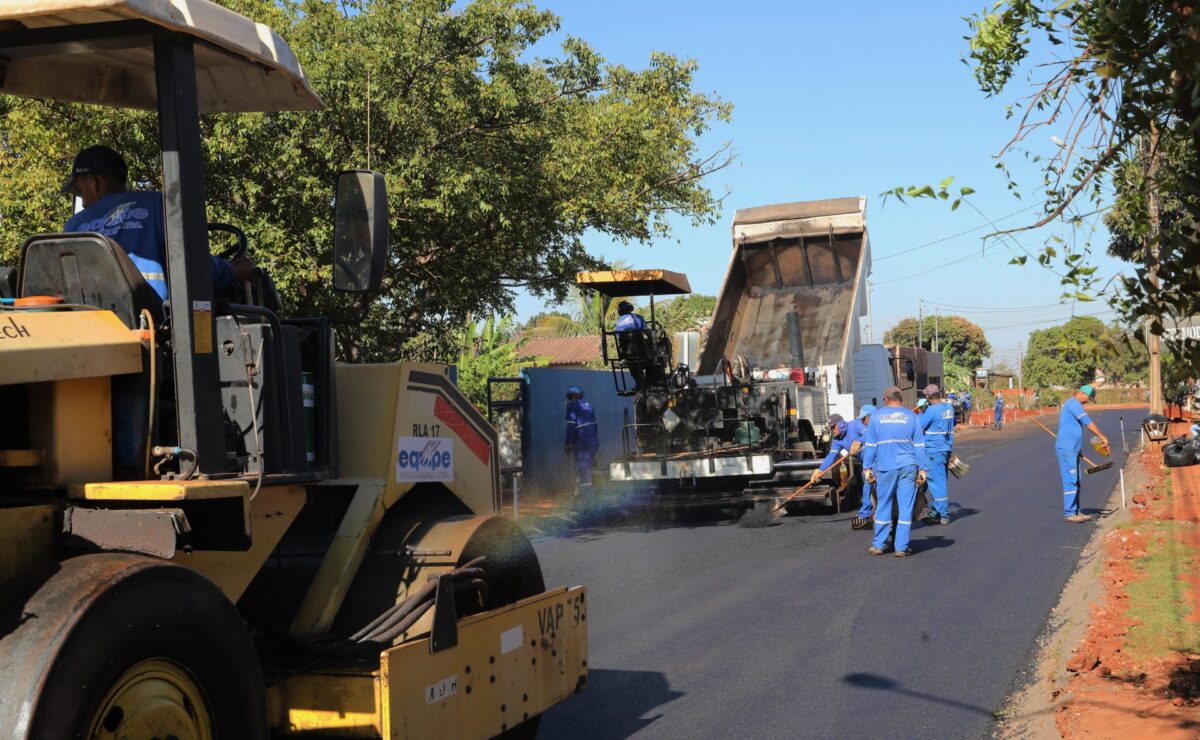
[0,0,323,113]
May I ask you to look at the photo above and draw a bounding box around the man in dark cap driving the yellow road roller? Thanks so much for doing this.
[62,146,254,300]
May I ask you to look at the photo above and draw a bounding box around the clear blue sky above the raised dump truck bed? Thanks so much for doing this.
[517,0,1123,363]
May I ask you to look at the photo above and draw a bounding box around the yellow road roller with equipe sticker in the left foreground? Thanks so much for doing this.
[0,0,588,739]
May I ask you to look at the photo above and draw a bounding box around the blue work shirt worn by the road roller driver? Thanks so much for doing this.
[62,191,233,300]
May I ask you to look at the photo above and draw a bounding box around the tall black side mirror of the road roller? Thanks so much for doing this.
[334,170,388,293]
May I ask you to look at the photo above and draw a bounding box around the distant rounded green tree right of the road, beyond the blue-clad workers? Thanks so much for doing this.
[1022,317,1105,387]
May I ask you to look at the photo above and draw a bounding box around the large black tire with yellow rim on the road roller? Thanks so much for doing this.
[0,554,266,740]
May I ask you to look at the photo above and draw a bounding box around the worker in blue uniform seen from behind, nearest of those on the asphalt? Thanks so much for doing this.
[863,385,928,558]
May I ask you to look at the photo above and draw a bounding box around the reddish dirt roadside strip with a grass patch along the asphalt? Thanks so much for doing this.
[998,425,1200,739]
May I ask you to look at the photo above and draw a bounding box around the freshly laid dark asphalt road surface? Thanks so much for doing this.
[534,409,1144,739]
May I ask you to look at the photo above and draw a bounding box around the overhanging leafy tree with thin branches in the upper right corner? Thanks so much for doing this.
[968,0,1200,363]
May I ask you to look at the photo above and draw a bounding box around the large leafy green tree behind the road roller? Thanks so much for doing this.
[0,0,731,360]
